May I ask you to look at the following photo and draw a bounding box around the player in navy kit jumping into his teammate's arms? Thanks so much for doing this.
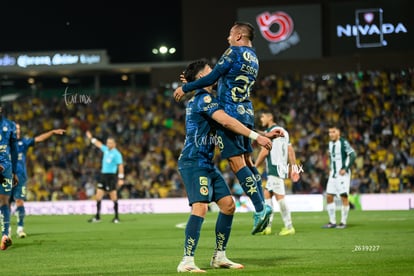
[174,22,273,235]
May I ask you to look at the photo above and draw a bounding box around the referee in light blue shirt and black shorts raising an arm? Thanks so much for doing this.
[86,131,125,223]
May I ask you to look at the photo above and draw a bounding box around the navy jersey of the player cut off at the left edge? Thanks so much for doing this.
[0,117,18,173]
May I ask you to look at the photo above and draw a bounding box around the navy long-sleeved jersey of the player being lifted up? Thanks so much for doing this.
[182,46,259,126]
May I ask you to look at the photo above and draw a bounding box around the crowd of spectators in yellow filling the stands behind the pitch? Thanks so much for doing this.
[9,68,414,201]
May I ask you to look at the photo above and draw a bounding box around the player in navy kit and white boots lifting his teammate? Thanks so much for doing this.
[177,59,271,272]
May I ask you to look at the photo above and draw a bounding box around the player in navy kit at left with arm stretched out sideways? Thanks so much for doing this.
[9,123,65,238]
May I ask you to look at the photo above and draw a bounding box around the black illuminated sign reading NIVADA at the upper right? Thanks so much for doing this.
[327,0,414,56]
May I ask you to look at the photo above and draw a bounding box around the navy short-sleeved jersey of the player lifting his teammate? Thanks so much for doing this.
[178,89,220,169]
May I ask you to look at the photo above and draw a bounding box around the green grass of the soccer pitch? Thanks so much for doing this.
[0,211,414,276]
